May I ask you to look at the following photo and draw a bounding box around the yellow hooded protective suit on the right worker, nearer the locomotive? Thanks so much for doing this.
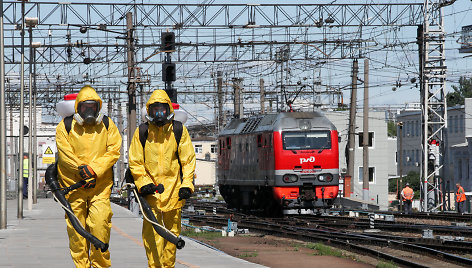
[129,90,195,267]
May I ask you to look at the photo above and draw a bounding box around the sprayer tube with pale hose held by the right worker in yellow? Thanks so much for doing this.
[124,169,185,249]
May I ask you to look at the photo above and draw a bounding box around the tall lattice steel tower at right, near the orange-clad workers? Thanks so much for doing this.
[418,0,447,214]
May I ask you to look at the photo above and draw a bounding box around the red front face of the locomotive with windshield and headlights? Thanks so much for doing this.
[273,125,339,213]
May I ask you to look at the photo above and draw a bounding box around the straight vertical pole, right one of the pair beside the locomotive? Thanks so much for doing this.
[362,59,369,209]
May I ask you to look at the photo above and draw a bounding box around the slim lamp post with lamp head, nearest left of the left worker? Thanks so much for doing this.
[25,18,38,210]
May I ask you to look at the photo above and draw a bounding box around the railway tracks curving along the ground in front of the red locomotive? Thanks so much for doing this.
[183,200,472,267]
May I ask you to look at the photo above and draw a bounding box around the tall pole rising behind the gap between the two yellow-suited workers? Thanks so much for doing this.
[126,12,136,148]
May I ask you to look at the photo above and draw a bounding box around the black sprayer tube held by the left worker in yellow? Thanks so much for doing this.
[45,164,108,252]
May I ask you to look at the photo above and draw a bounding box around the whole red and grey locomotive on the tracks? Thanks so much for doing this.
[217,112,339,214]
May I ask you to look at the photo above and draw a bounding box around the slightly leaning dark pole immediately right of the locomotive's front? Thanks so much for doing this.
[347,59,358,189]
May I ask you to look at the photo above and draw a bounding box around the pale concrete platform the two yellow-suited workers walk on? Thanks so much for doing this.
[0,199,264,268]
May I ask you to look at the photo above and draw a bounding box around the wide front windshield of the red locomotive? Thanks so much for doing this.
[282,131,331,150]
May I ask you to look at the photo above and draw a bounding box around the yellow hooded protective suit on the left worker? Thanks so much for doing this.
[56,86,121,268]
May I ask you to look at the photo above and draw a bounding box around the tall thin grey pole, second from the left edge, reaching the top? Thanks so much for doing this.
[16,0,28,219]
